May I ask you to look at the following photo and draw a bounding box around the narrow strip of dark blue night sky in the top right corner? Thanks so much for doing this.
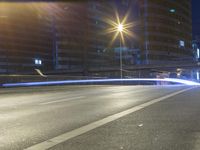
[192,0,200,37]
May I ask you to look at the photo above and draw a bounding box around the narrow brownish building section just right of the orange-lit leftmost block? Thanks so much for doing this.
[49,2,87,70]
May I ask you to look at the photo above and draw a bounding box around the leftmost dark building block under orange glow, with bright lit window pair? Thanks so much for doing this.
[0,2,53,73]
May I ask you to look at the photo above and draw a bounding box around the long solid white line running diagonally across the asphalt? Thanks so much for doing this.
[25,87,196,150]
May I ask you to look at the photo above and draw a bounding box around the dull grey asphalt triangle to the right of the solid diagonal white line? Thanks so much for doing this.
[50,88,200,150]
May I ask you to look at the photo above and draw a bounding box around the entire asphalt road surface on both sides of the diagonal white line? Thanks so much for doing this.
[0,86,200,150]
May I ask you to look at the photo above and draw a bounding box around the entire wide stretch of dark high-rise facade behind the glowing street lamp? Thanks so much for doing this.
[0,0,193,75]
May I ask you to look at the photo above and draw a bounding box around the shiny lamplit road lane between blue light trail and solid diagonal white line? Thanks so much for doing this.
[0,86,190,150]
